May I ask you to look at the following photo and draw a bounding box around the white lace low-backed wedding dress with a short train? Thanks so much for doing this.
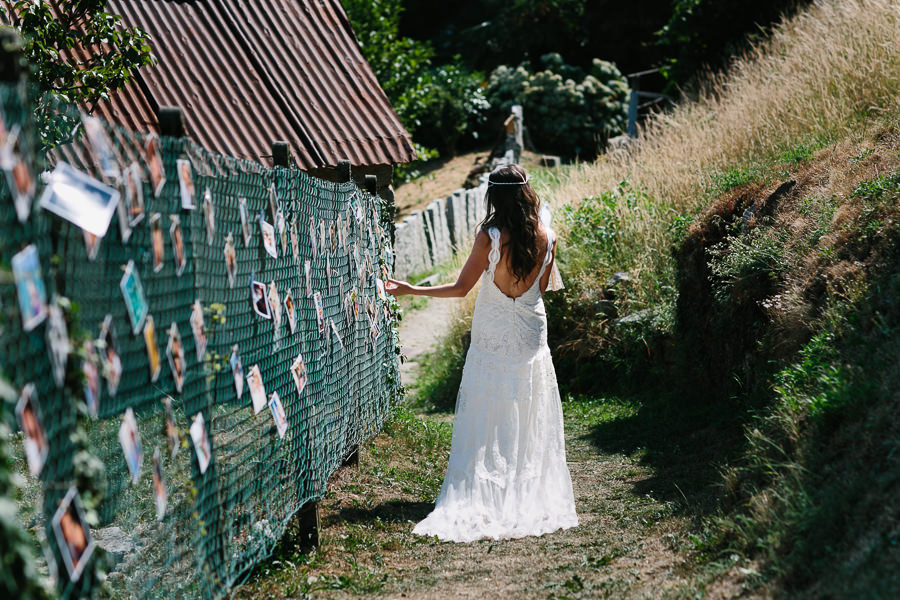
[413,228,578,542]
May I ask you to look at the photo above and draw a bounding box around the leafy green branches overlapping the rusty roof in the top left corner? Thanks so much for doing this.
[0,0,155,111]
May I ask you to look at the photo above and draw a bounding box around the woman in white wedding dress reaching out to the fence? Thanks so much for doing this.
[385,165,578,542]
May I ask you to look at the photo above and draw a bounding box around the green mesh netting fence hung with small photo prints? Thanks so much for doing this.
[0,88,399,598]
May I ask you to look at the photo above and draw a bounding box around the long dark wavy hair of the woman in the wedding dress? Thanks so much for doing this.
[481,165,540,283]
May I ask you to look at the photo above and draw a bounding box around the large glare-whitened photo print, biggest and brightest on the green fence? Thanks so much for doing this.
[40,162,120,237]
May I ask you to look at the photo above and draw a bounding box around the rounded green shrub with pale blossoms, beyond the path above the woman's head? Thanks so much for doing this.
[485,53,628,158]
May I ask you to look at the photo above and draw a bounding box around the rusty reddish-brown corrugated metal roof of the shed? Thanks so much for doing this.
[94,0,415,169]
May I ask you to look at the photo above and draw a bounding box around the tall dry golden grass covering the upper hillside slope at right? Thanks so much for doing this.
[554,0,900,303]
